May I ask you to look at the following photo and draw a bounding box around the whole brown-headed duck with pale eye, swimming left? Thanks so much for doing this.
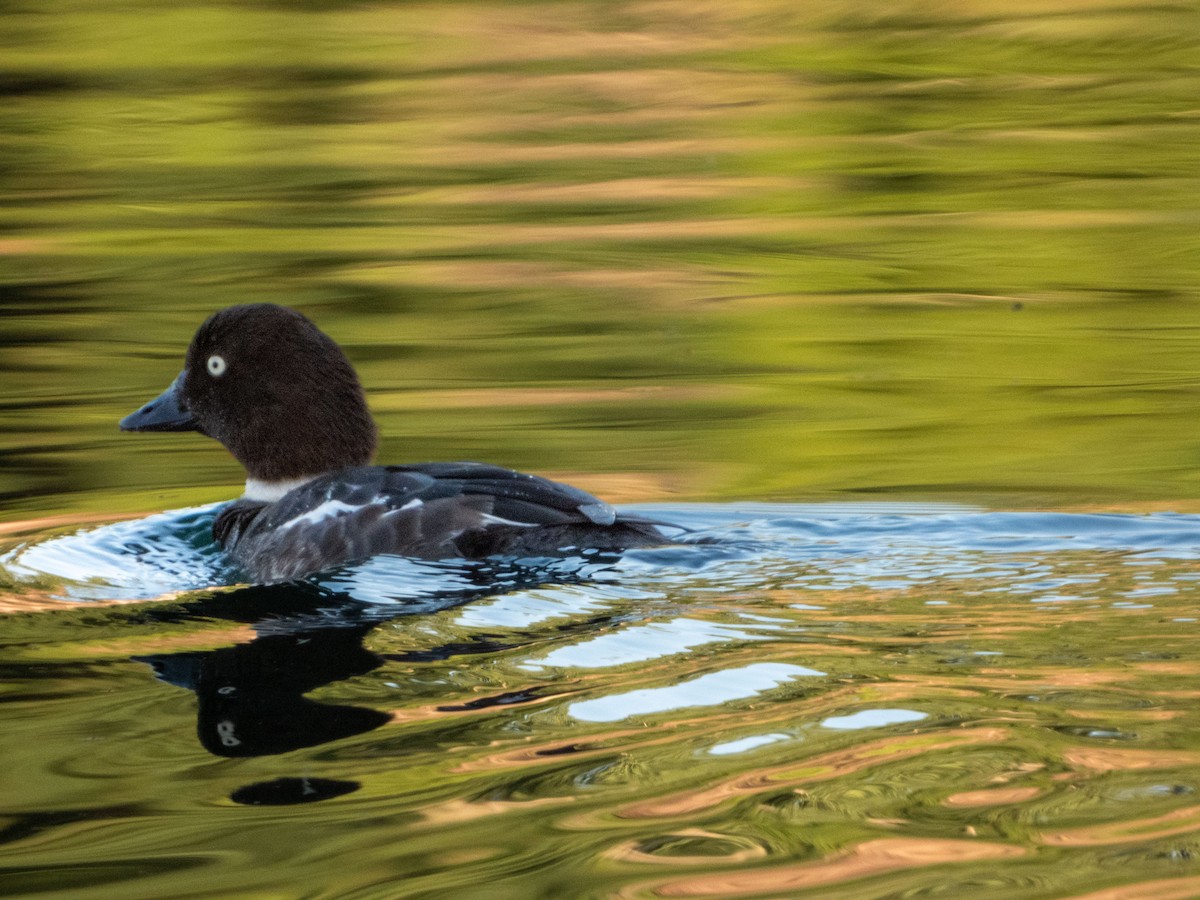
[120,304,668,582]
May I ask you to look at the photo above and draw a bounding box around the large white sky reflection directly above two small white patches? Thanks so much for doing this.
[568,662,824,722]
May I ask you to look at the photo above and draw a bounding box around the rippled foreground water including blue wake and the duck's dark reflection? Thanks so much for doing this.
[2,503,1200,898]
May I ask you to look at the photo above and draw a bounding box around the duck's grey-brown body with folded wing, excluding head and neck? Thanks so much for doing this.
[214,462,662,581]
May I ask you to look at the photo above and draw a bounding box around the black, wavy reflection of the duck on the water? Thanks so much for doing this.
[134,554,617,804]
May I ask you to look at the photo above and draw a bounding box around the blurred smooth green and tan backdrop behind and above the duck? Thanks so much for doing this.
[0,0,1200,521]
